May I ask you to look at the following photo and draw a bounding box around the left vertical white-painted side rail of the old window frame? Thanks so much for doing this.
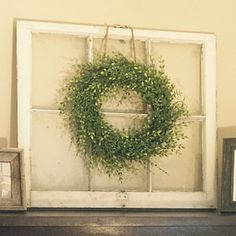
[17,22,32,206]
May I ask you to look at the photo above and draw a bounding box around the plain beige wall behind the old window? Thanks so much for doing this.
[0,0,236,146]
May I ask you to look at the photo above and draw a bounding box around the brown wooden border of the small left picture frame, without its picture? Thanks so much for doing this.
[0,148,26,211]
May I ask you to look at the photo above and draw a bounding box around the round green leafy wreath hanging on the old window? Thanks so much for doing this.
[59,54,189,178]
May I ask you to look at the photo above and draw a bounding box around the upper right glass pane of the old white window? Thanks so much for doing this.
[152,43,202,115]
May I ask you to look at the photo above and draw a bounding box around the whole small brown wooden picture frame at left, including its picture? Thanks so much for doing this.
[0,148,26,211]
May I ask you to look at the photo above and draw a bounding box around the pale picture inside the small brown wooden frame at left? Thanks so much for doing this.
[0,162,11,199]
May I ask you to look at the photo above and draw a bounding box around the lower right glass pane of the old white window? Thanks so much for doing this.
[152,121,203,192]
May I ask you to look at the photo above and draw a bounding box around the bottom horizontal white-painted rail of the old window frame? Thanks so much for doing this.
[31,191,215,208]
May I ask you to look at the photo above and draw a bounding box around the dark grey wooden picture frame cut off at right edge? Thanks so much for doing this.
[220,138,236,212]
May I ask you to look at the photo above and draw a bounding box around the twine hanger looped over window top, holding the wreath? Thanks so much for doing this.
[101,25,136,62]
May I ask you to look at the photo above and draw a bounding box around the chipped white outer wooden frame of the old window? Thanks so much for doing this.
[17,21,216,208]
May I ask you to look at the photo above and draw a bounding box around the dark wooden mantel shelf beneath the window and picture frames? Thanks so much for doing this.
[0,211,236,236]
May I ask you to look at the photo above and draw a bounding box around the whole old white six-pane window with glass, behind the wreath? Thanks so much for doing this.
[18,22,215,208]
